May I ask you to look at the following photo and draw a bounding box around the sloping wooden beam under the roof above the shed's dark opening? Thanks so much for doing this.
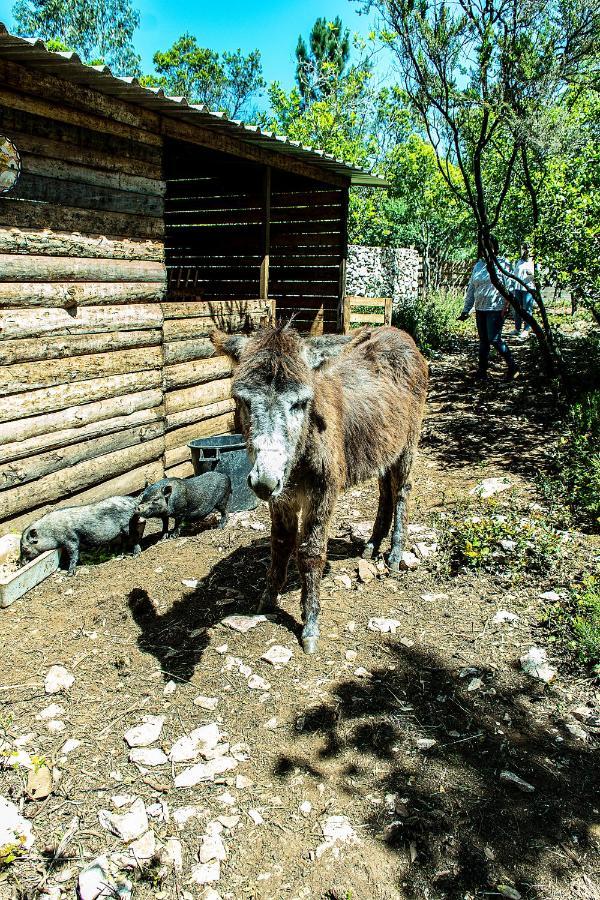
[163,117,350,187]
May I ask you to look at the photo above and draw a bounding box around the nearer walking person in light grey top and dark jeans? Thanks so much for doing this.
[458,237,517,381]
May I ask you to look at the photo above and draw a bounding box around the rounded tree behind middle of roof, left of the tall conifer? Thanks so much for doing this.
[142,34,265,118]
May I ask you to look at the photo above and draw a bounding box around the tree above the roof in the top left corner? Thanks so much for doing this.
[13,0,141,75]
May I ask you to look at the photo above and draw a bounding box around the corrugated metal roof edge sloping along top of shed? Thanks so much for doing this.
[0,22,386,187]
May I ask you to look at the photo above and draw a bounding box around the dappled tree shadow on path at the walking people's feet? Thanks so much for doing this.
[421,339,557,476]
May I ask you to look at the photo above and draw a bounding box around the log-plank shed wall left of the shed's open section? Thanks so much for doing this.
[0,61,165,532]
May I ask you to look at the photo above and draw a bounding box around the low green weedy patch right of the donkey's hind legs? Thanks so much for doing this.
[438,499,564,574]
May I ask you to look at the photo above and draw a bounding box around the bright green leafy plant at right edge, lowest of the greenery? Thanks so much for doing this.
[542,575,600,675]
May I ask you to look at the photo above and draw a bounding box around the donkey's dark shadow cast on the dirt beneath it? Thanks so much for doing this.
[127,538,366,682]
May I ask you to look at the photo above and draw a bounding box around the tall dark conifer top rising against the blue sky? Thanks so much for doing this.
[296,16,350,105]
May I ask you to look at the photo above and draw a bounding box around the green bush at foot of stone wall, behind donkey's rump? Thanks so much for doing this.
[392,289,465,356]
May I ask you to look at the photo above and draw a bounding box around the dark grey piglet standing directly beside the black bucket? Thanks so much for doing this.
[137,472,231,538]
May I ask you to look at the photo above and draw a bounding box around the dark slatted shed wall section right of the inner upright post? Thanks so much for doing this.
[269,170,347,334]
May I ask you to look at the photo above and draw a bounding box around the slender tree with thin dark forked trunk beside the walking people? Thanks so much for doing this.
[369,0,600,371]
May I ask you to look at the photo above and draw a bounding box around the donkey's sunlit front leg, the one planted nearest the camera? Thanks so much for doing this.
[298,506,333,653]
